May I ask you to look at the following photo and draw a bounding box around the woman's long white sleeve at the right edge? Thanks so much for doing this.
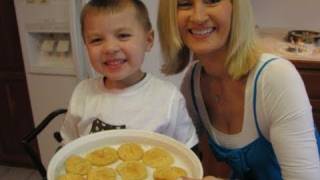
[260,59,320,179]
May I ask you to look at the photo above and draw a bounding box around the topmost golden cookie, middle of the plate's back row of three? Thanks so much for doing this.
[118,143,144,161]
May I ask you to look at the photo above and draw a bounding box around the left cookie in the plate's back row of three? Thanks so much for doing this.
[86,147,118,166]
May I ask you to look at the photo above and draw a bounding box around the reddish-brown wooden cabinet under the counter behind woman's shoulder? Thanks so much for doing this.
[291,59,320,130]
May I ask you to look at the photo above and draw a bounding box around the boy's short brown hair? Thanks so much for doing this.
[80,0,152,37]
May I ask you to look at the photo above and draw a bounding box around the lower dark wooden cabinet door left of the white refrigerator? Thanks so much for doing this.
[0,79,37,166]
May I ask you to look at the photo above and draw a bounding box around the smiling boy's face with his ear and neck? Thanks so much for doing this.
[84,6,153,87]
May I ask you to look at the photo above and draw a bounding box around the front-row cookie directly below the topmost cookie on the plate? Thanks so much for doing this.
[116,161,148,180]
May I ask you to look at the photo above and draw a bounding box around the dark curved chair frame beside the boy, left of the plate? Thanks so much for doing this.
[21,109,67,180]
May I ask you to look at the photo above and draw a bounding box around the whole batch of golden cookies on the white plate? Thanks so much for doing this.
[57,143,187,180]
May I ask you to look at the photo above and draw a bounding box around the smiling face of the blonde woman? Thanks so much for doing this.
[177,0,232,55]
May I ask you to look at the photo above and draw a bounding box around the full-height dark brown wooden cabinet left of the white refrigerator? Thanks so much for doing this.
[0,0,37,167]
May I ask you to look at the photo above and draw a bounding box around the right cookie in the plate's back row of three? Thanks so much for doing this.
[143,147,174,168]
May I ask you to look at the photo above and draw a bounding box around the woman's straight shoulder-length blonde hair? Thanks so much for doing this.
[158,0,261,79]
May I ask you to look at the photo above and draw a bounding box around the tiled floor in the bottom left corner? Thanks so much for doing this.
[0,165,42,180]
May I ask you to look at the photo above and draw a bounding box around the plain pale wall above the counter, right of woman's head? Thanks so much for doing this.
[251,0,320,30]
